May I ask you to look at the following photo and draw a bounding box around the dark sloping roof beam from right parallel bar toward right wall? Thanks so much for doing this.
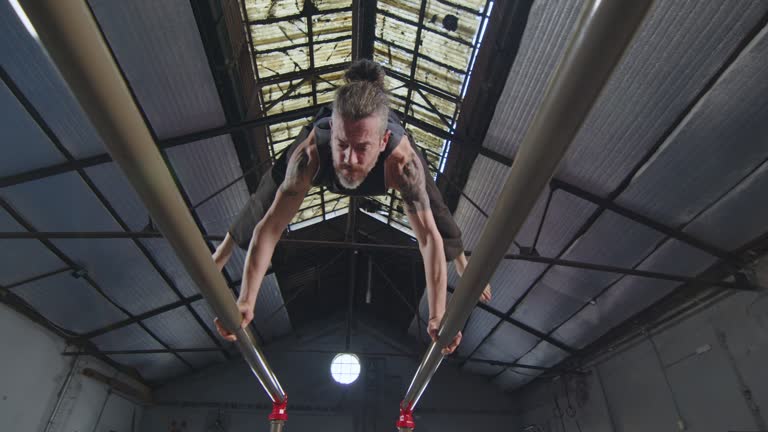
[551,179,738,262]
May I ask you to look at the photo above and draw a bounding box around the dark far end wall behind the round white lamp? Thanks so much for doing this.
[142,318,519,432]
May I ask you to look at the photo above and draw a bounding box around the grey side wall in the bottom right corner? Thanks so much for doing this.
[512,261,768,432]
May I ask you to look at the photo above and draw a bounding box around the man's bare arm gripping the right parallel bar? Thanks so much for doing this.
[395,152,461,354]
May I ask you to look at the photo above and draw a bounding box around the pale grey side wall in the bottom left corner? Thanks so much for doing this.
[0,305,142,432]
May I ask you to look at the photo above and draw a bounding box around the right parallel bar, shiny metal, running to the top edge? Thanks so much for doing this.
[401,0,651,410]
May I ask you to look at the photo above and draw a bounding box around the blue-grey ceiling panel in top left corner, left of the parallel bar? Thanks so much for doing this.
[0,1,104,157]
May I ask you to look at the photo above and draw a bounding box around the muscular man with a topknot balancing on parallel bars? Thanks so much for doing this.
[213,60,491,354]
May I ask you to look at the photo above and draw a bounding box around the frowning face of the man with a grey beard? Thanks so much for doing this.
[331,114,390,189]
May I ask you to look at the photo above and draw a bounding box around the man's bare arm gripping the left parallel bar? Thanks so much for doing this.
[216,132,317,341]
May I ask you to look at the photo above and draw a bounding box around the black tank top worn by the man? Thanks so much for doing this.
[312,107,405,196]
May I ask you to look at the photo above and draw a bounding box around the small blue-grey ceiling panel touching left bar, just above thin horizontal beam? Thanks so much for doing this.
[85,162,149,231]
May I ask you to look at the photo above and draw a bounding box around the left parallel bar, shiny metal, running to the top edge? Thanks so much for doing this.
[21,0,286,402]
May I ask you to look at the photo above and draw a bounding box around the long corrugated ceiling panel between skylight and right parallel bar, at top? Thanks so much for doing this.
[483,0,582,156]
